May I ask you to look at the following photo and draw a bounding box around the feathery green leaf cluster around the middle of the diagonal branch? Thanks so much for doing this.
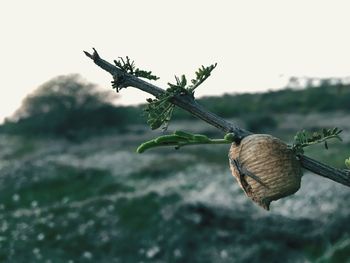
[145,63,217,130]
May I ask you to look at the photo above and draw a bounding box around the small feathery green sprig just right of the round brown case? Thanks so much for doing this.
[292,128,342,154]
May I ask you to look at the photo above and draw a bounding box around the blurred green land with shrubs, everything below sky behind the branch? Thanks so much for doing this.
[0,75,350,263]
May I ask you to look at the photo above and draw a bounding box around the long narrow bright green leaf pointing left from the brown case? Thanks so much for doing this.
[136,131,235,153]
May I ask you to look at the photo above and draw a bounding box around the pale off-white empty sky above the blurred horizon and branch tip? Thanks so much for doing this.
[0,0,350,124]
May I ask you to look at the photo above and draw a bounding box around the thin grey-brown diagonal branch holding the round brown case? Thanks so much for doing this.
[84,49,350,189]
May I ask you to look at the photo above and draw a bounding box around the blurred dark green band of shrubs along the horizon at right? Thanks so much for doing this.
[198,85,350,118]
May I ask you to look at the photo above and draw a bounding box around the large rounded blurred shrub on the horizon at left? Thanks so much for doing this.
[1,75,140,139]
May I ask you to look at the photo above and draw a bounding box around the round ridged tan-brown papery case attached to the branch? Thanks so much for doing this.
[229,134,302,210]
